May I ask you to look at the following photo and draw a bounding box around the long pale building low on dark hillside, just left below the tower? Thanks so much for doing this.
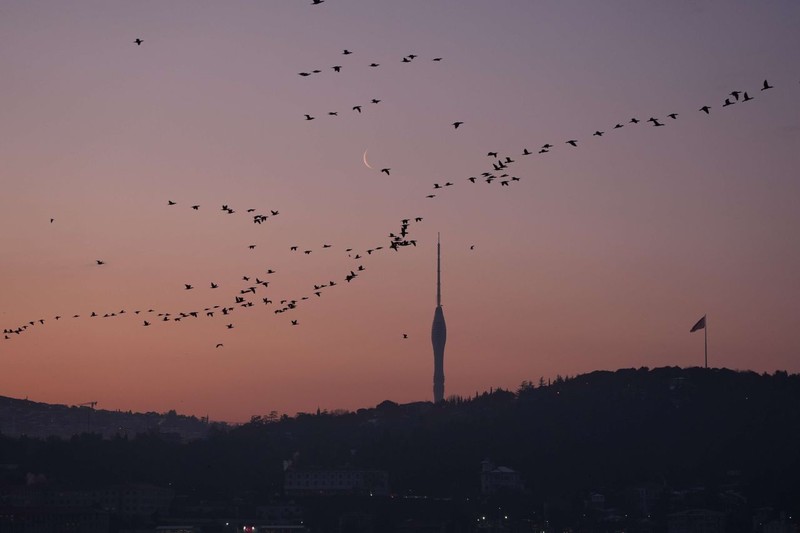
[283,468,389,496]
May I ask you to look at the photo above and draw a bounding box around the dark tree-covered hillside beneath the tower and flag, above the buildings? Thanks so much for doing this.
[0,368,800,510]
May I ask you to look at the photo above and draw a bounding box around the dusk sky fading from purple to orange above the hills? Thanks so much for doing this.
[0,0,800,422]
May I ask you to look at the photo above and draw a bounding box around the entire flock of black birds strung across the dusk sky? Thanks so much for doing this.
[3,32,788,348]
